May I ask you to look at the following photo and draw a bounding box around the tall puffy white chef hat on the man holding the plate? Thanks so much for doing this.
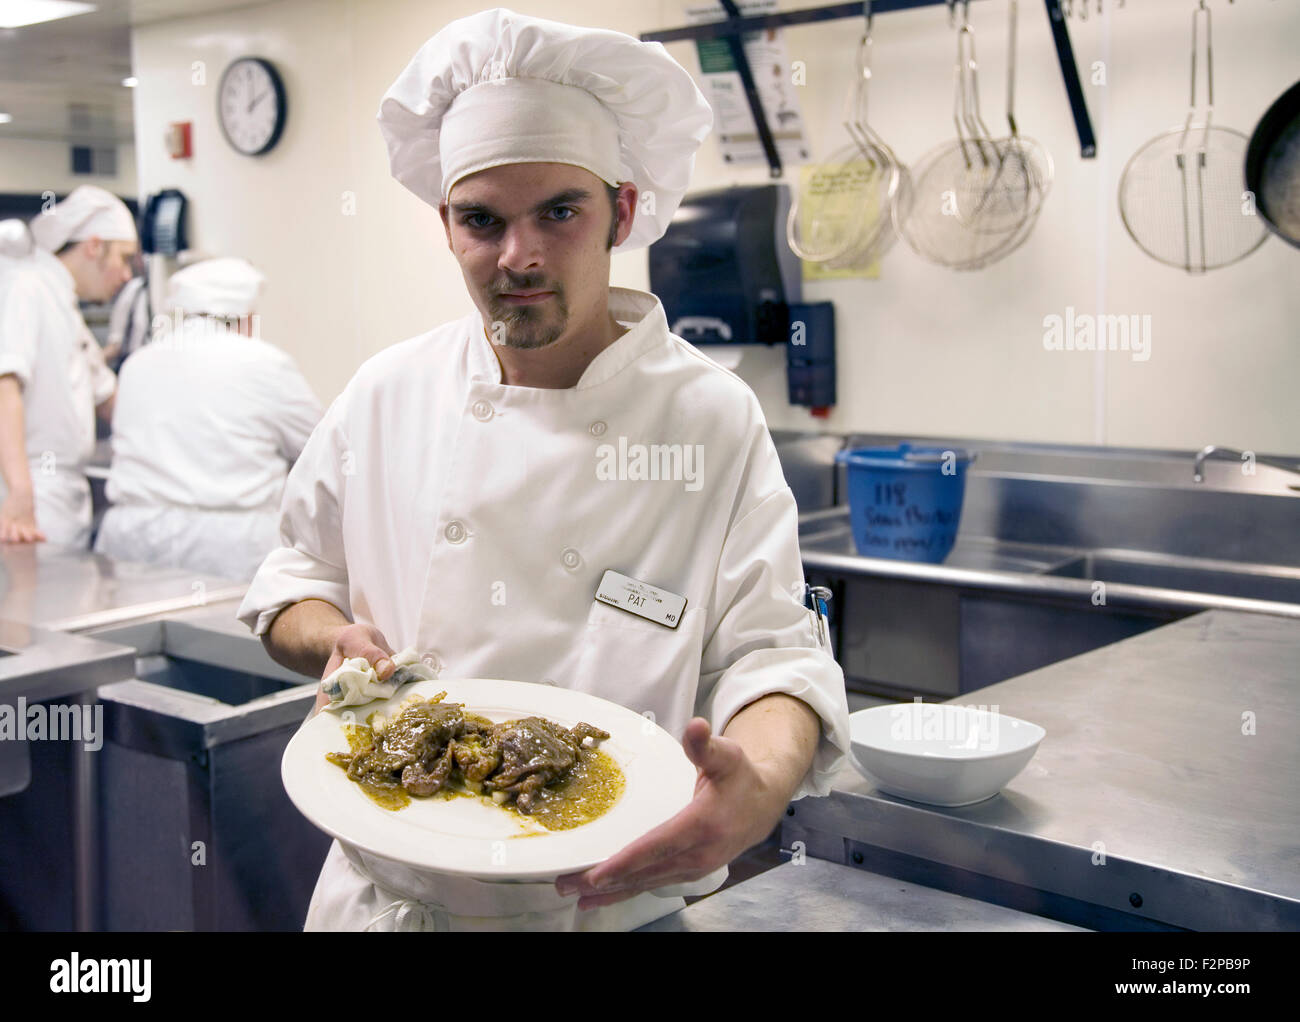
[378,8,714,252]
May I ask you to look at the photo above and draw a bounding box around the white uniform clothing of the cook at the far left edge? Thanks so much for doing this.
[0,248,116,549]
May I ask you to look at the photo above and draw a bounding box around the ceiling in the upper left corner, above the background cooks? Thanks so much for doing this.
[0,0,265,144]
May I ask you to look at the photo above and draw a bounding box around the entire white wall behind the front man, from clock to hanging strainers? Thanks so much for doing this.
[134,0,1300,452]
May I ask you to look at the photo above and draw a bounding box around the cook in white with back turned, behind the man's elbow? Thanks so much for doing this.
[95,259,322,581]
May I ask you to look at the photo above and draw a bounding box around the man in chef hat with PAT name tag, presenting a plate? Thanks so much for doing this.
[239,9,849,930]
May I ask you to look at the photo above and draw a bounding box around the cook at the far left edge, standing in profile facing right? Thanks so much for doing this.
[0,185,138,550]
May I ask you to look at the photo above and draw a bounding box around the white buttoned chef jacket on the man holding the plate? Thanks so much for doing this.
[238,287,849,928]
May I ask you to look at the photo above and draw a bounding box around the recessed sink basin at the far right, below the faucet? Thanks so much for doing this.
[1044,550,1300,603]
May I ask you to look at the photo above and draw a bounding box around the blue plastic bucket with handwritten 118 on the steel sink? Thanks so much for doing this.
[835,443,975,564]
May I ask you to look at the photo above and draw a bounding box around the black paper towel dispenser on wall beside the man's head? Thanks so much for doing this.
[650,183,802,345]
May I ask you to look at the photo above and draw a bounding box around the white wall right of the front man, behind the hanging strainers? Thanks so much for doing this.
[712,0,1300,452]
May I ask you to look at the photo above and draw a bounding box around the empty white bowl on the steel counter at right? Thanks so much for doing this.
[849,702,1047,806]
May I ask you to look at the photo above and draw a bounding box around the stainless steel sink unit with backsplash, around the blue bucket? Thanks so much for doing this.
[774,434,1300,698]
